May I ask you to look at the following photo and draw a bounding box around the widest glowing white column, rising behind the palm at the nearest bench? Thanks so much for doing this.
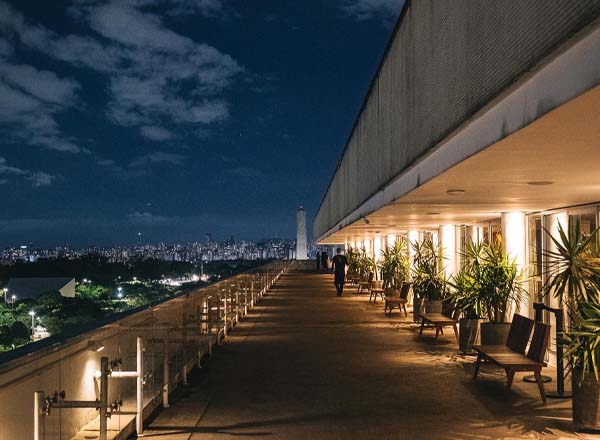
[501,211,530,316]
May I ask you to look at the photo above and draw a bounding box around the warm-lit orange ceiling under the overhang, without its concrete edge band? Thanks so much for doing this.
[320,86,600,244]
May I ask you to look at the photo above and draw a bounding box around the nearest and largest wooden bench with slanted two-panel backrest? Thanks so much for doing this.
[473,315,550,404]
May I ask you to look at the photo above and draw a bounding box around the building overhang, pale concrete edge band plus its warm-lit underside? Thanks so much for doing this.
[315,19,600,244]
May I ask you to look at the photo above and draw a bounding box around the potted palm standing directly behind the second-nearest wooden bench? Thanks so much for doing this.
[411,237,447,321]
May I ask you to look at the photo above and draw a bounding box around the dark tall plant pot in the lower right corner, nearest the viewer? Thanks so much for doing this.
[573,368,600,430]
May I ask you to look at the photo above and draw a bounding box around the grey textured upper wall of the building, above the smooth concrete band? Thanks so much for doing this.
[314,0,600,241]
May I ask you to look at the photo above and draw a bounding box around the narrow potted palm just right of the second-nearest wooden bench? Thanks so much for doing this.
[449,242,484,353]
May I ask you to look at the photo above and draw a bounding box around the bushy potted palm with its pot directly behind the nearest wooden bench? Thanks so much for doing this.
[471,240,527,345]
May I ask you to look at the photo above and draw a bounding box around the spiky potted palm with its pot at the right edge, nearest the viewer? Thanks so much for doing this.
[544,219,600,430]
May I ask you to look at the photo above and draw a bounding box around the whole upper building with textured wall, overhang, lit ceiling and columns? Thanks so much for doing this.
[314,0,600,362]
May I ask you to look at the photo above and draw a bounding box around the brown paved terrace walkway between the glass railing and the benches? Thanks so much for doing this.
[146,271,599,440]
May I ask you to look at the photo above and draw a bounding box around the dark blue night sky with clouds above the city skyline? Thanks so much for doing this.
[0,0,402,247]
